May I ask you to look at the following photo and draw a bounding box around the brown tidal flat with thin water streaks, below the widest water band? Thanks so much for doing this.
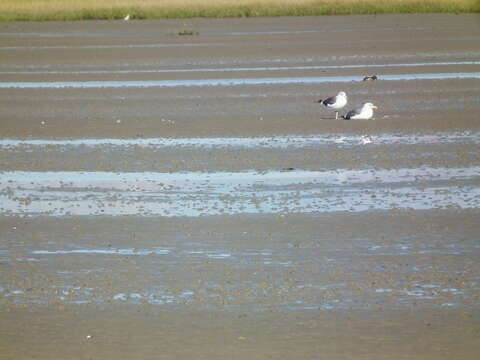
[0,209,480,359]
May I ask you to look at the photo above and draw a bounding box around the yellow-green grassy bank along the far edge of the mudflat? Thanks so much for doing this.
[0,0,480,21]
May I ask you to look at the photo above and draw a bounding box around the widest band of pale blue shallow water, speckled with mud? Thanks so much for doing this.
[0,167,480,217]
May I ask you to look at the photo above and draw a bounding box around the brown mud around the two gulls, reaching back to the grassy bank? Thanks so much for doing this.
[0,15,480,138]
